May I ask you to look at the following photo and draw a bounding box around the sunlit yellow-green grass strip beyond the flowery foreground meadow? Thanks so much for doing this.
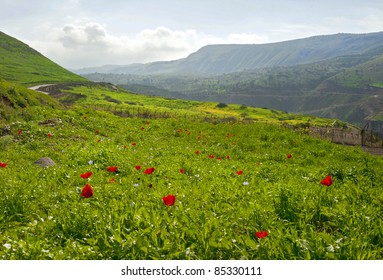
[59,83,345,126]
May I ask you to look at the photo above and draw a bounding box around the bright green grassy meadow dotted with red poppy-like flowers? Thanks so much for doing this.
[0,83,383,260]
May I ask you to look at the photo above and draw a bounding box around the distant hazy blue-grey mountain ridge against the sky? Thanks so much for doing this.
[74,32,383,75]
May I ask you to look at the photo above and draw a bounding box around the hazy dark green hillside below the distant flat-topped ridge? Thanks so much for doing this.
[89,48,383,125]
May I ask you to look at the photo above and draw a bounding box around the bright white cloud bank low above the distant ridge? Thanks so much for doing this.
[28,22,267,68]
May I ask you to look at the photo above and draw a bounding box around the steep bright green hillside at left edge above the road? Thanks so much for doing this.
[0,31,86,85]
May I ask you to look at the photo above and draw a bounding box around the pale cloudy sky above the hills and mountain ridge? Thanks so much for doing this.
[0,0,383,69]
